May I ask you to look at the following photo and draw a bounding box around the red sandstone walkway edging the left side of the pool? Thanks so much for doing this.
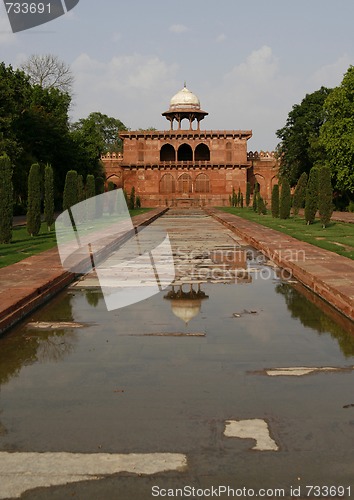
[0,208,168,335]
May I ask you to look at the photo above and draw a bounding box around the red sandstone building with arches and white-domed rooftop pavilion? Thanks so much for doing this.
[102,87,278,207]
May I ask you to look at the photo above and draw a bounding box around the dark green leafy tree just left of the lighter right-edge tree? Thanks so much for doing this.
[276,87,331,185]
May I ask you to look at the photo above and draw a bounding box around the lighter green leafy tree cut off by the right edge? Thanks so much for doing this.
[320,66,354,193]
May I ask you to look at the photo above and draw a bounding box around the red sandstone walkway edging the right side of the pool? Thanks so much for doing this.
[205,209,354,321]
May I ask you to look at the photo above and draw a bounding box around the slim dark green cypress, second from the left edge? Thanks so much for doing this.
[27,163,41,236]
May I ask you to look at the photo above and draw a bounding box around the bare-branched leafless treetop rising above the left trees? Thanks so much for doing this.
[21,54,74,94]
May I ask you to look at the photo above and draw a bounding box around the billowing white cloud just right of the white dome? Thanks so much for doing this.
[206,45,297,150]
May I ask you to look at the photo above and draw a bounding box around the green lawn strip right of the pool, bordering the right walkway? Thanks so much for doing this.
[218,207,354,259]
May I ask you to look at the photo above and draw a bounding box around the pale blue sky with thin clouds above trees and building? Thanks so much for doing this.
[0,0,354,151]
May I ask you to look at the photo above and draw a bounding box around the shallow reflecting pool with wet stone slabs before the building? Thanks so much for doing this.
[0,211,354,500]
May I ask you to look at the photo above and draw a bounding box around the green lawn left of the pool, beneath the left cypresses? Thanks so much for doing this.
[0,208,151,268]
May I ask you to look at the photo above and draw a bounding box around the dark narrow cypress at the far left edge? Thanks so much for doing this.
[0,155,13,243]
